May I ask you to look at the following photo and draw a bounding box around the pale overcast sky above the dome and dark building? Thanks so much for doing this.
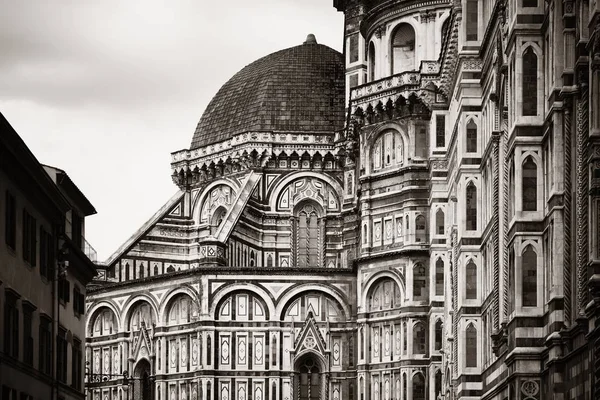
[0,0,343,261]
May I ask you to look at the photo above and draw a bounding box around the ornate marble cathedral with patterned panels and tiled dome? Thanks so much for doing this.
[86,0,600,400]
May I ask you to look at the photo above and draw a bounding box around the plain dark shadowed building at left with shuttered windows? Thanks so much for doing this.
[0,114,96,400]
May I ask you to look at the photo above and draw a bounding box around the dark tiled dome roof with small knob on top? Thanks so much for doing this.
[190,35,345,149]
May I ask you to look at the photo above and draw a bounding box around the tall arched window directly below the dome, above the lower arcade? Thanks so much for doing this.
[292,201,324,268]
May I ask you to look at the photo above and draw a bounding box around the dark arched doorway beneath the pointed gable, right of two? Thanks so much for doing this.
[294,353,328,400]
